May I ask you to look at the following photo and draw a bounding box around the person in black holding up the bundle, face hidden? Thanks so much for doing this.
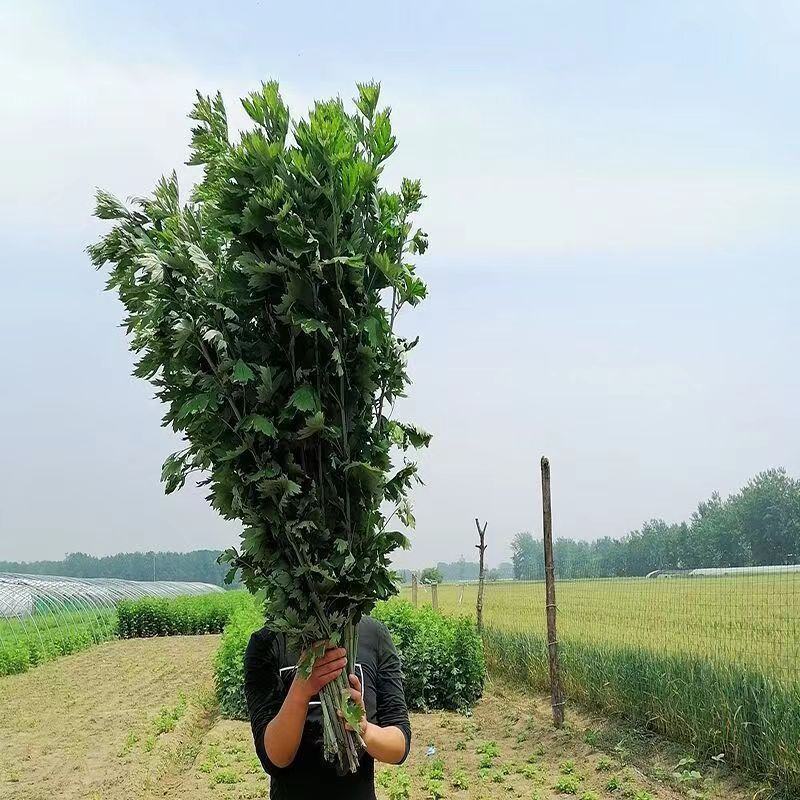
[244,617,411,800]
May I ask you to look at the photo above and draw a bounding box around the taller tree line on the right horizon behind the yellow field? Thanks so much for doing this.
[511,469,800,580]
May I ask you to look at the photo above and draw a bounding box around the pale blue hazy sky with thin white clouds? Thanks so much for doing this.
[0,0,800,566]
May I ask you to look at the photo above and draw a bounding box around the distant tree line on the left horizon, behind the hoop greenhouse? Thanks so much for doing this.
[0,550,236,586]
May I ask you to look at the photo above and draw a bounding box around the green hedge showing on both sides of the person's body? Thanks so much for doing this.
[215,599,486,719]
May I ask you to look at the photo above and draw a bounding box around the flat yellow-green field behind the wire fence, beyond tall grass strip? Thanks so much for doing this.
[403,574,800,683]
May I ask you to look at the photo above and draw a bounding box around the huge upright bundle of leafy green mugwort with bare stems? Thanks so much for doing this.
[89,82,430,771]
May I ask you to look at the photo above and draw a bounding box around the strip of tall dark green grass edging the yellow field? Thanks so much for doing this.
[484,627,800,796]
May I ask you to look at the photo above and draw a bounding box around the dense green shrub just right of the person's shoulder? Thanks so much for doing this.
[372,600,486,711]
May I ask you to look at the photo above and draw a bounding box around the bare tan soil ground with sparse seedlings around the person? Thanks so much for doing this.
[0,636,766,800]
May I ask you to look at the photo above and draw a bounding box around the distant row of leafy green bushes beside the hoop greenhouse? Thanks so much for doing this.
[117,592,247,639]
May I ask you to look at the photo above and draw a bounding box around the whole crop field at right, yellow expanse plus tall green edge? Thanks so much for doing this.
[406,575,800,796]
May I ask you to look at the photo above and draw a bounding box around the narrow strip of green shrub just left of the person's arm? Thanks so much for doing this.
[214,600,264,719]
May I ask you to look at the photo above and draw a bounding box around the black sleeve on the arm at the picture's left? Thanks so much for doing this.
[244,632,283,775]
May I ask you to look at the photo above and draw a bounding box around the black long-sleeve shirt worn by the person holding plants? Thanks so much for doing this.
[244,617,411,800]
